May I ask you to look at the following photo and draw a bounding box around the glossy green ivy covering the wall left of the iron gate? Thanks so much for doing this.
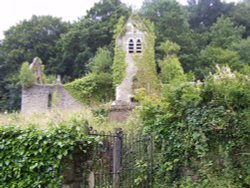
[0,116,94,188]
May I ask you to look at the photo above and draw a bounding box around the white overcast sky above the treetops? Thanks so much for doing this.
[0,0,239,39]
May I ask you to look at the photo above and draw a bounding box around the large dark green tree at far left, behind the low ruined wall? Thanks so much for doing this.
[0,16,69,111]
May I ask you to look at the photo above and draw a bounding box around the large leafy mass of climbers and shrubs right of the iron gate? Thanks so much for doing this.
[138,67,250,187]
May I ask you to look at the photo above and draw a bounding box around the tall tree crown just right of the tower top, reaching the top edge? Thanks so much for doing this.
[141,0,188,44]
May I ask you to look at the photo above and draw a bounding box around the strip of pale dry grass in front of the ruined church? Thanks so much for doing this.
[0,105,139,133]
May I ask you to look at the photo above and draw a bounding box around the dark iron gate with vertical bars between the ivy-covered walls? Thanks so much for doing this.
[89,128,154,188]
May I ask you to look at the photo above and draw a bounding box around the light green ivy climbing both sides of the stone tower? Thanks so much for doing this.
[113,14,159,94]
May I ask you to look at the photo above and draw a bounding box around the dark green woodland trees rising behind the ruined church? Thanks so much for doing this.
[0,0,250,112]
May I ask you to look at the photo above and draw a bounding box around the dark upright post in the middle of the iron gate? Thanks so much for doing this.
[113,128,122,188]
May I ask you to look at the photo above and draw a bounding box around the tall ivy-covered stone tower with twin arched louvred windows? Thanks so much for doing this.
[112,15,158,120]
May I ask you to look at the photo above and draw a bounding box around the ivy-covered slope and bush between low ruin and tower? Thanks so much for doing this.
[64,48,114,104]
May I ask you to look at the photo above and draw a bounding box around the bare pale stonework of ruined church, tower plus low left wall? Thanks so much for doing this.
[21,15,157,121]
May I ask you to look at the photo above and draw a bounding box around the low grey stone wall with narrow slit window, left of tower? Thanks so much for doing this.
[21,84,81,114]
